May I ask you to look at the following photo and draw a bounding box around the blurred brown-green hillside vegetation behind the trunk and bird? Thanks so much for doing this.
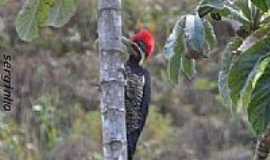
[0,0,255,160]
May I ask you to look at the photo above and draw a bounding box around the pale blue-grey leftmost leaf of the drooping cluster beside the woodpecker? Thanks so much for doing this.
[164,16,185,59]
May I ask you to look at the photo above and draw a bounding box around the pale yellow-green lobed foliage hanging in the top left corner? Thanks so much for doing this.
[16,0,78,41]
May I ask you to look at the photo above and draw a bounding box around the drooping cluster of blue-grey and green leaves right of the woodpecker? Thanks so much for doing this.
[164,15,216,84]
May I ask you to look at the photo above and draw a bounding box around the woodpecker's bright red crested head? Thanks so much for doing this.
[131,29,155,59]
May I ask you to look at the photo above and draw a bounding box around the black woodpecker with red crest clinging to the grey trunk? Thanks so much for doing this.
[125,29,155,160]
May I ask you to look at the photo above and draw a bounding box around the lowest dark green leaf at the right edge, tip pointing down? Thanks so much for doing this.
[248,64,270,135]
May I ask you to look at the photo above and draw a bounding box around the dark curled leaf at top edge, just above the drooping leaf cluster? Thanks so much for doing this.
[197,0,224,17]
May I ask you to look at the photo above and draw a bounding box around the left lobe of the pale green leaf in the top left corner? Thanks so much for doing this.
[16,0,54,41]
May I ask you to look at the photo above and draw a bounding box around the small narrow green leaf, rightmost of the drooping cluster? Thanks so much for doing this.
[204,20,217,49]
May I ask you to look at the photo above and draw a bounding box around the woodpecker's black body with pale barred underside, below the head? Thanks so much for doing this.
[125,55,151,160]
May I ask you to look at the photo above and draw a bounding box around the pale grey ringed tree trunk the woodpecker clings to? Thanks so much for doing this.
[98,0,127,160]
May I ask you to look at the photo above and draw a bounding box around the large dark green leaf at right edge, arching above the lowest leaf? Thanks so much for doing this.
[228,38,270,105]
